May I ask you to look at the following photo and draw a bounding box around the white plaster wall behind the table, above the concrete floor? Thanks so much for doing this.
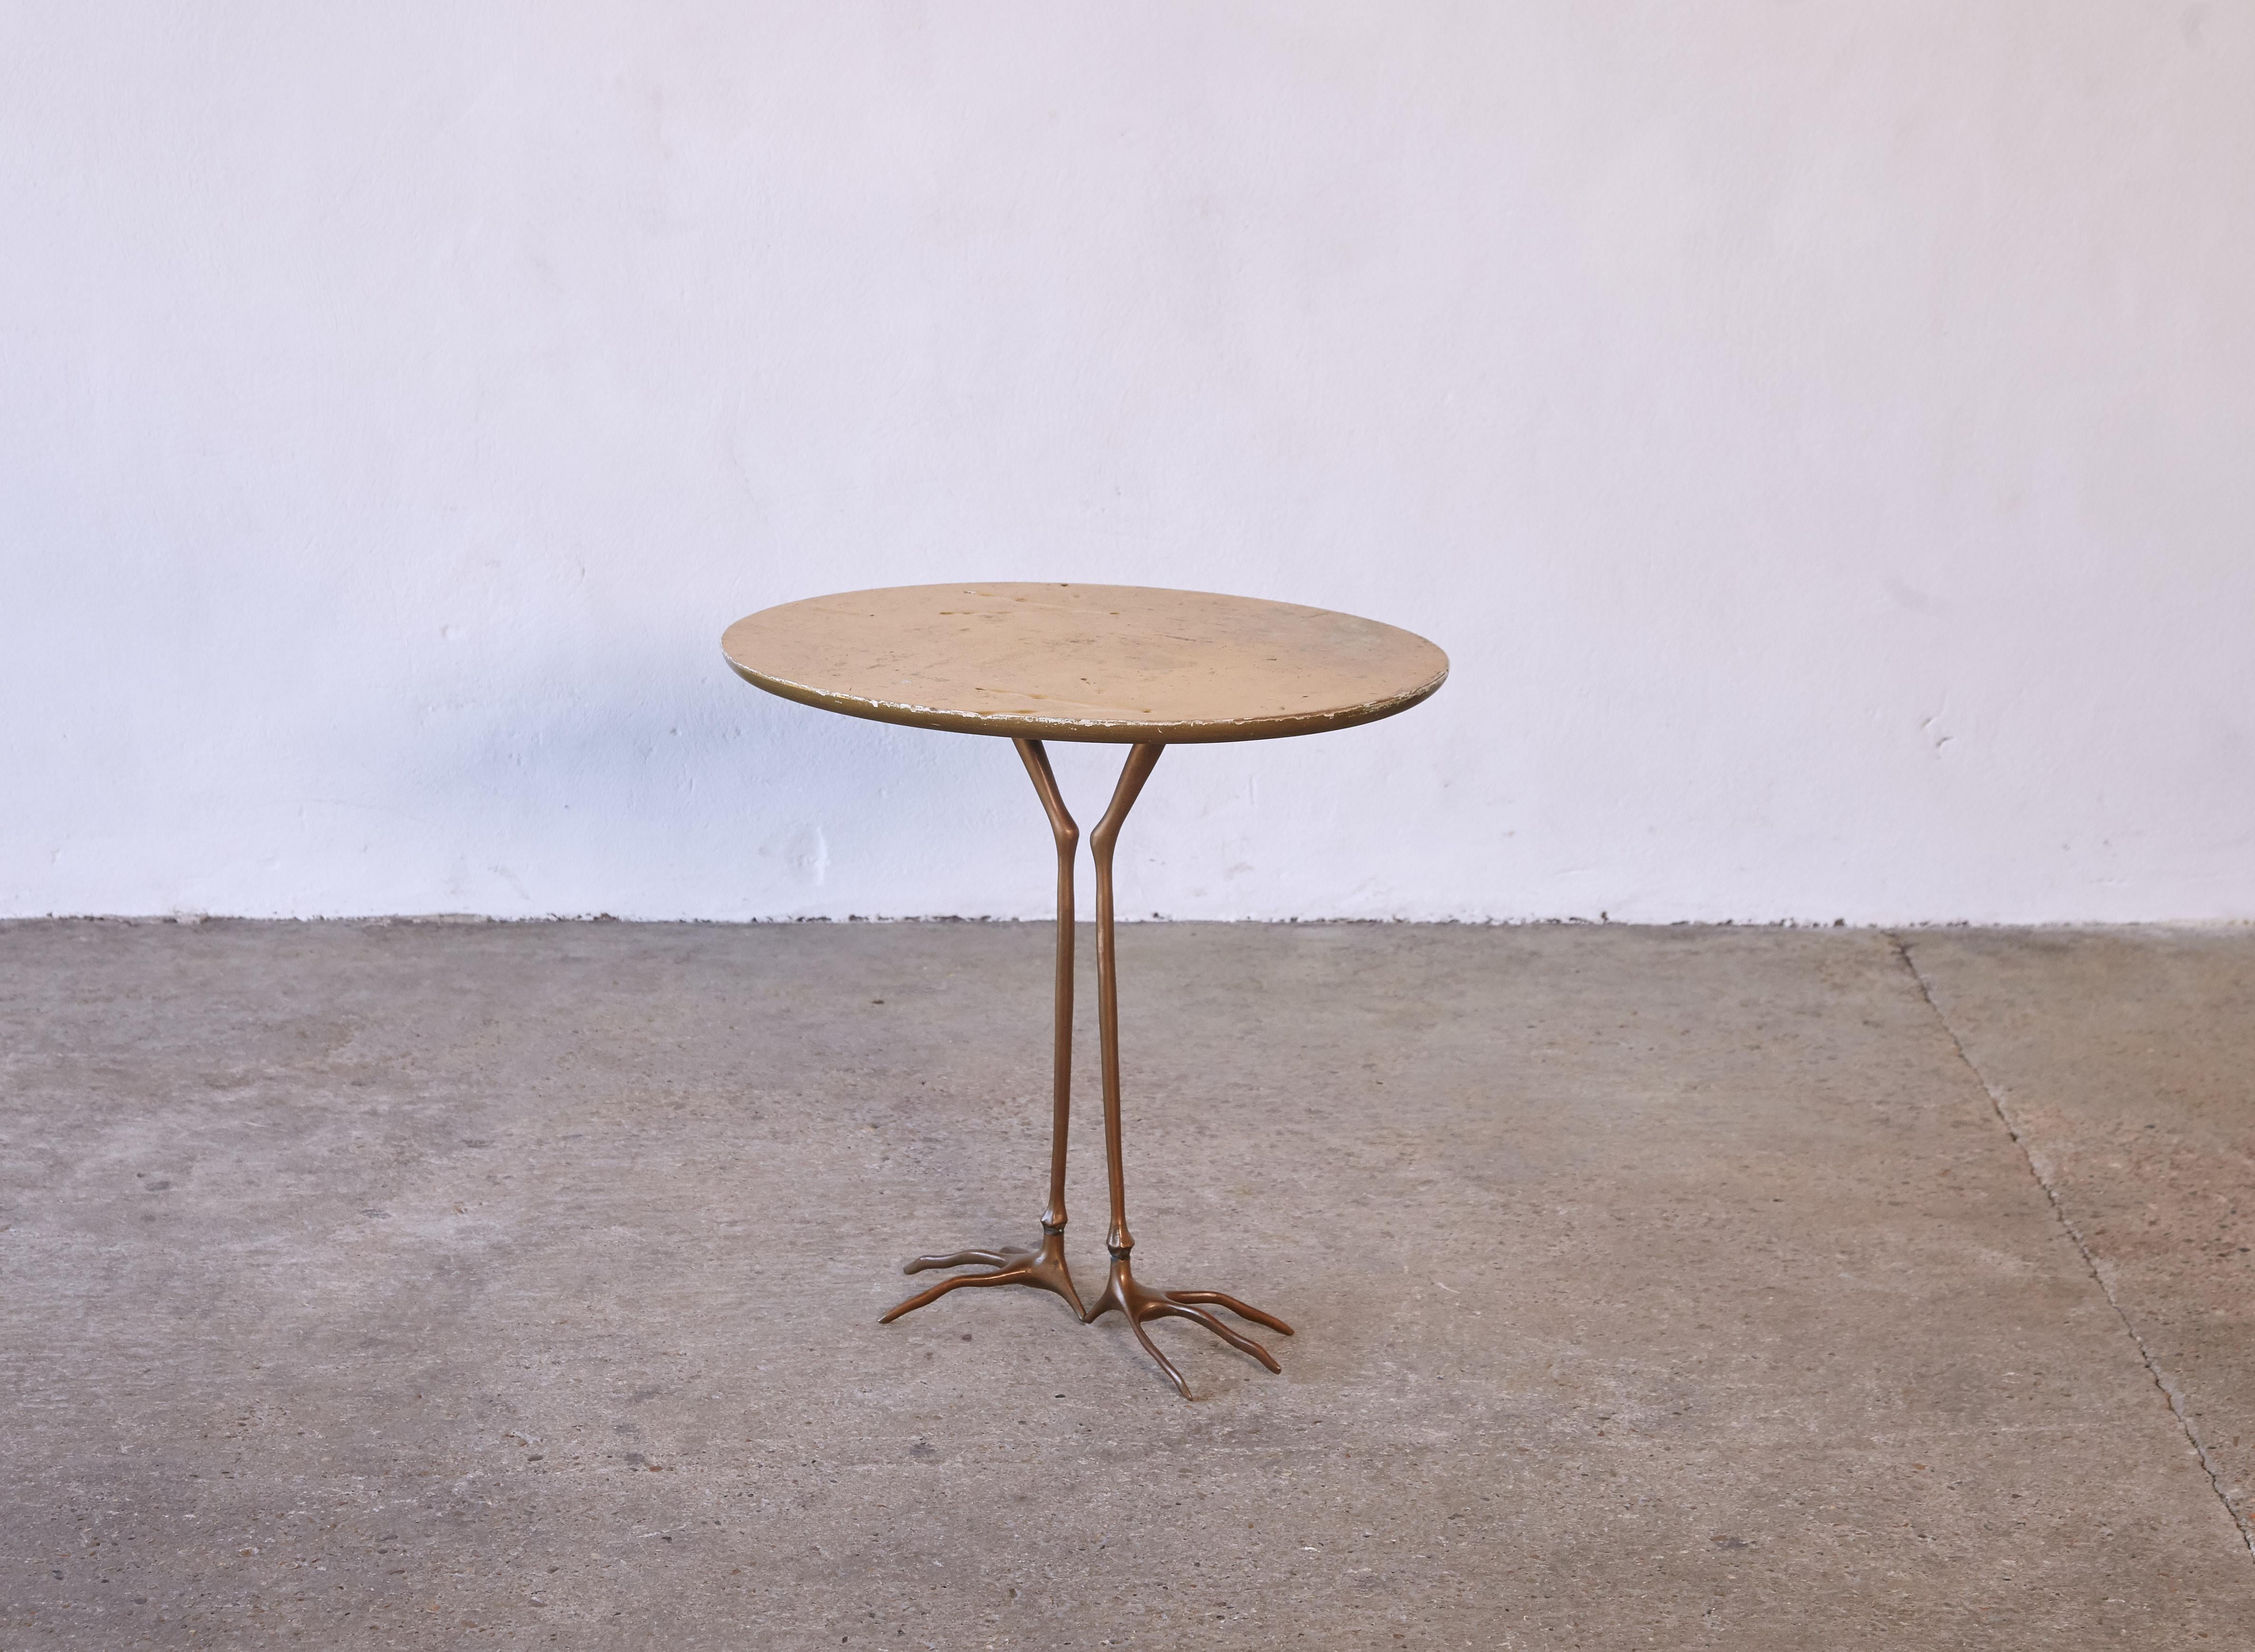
[0,0,2255,922]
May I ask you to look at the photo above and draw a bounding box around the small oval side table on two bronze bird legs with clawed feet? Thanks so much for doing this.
[721,584,1448,1400]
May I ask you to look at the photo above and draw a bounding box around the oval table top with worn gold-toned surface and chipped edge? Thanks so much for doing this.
[721,584,1448,744]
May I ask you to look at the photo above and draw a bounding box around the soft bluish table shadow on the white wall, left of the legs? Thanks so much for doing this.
[386,645,1046,920]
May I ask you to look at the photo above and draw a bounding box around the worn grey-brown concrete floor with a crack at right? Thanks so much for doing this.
[0,922,2255,1652]
